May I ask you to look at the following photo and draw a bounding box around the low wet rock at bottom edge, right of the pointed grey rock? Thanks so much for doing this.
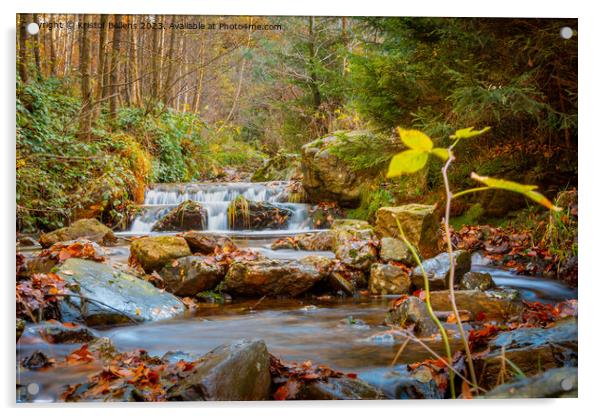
[297,376,385,400]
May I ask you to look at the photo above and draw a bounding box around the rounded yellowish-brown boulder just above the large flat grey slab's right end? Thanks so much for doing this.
[129,236,192,273]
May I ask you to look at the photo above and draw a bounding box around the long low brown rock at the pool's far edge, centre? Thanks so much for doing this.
[223,259,323,297]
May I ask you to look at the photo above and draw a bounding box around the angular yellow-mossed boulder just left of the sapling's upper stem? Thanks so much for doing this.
[374,204,440,258]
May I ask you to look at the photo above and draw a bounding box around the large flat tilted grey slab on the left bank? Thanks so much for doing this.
[57,258,185,326]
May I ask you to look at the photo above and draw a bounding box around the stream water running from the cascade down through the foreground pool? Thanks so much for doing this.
[17,182,577,402]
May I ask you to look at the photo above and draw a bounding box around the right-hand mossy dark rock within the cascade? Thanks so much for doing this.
[228,196,293,230]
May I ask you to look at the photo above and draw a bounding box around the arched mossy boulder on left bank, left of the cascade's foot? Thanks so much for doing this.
[40,219,117,248]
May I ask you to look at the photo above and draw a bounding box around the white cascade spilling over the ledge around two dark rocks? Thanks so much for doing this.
[129,182,311,234]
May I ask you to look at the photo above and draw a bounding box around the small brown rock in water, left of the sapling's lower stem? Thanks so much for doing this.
[385,296,439,337]
